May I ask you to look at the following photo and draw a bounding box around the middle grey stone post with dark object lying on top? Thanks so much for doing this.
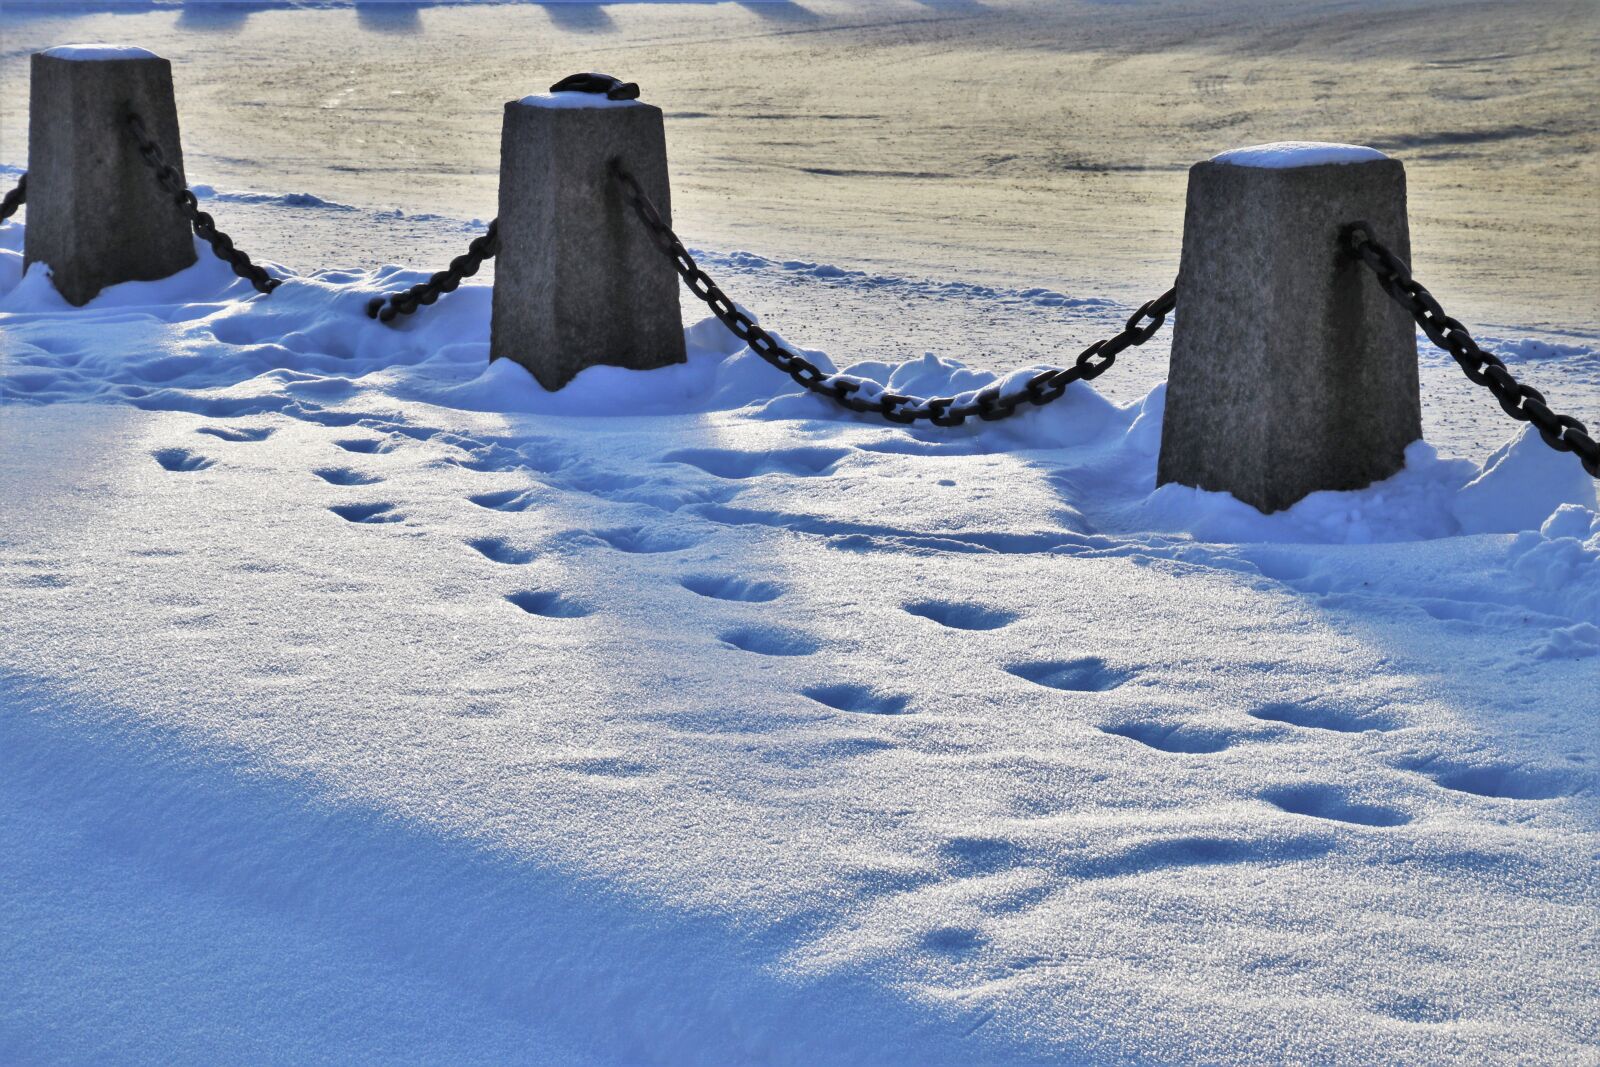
[490,83,685,390]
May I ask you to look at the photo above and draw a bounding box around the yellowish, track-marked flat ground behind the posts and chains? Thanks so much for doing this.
[0,0,1600,334]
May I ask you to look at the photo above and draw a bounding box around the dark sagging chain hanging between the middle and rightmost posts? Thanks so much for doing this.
[611,160,1178,426]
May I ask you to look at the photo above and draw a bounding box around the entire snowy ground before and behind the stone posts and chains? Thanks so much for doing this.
[0,0,1600,1065]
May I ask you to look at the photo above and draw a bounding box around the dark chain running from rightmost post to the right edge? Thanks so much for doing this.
[1346,222,1600,478]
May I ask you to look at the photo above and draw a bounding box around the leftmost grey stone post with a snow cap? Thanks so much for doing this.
[22,45,195,306]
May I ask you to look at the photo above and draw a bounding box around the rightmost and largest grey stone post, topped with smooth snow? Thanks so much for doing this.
[1157,142,1422,512]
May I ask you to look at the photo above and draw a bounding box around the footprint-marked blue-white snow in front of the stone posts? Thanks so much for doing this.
[0,212,1600,1064]
